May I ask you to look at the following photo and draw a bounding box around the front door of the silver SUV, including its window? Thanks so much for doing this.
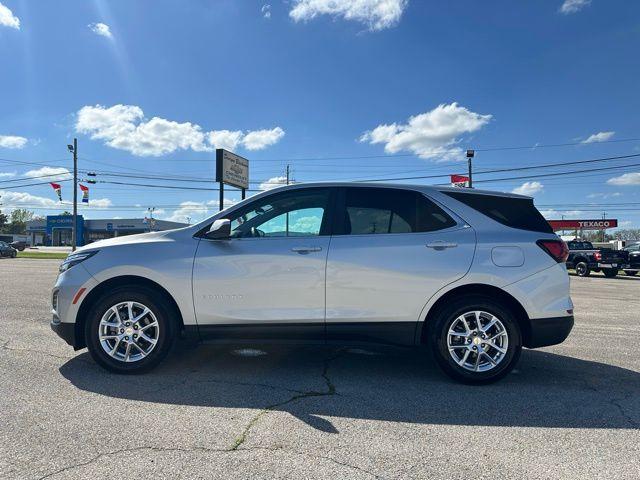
[193,188,332,341]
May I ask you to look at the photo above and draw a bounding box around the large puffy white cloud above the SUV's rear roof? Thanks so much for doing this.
[360,102,492,159]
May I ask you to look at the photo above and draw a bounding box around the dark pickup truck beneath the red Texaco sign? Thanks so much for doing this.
[567,241,629,278]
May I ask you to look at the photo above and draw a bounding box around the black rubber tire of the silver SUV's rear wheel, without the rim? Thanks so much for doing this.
[428,295,522,385]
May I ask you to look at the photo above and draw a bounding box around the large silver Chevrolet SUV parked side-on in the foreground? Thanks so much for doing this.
[51,183,573,383]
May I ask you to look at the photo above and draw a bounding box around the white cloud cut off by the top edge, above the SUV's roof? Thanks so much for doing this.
[289,0,408,31]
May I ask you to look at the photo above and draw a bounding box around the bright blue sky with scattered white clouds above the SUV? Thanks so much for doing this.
[0,0,640,227]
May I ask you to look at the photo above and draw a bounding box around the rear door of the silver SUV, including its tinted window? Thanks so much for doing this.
[327,187,476,345]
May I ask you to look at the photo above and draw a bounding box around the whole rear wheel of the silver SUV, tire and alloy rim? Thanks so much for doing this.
[429,295,522,384]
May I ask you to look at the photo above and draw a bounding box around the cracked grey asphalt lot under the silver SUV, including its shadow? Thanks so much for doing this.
[0,259,640,480]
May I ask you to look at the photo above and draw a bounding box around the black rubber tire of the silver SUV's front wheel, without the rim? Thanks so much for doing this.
[85,286,178,374]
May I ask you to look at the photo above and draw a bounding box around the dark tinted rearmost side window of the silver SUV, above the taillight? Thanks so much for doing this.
[442,192,553,233]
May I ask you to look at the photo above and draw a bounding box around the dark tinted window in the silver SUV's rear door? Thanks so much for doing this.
[337,187,456,235]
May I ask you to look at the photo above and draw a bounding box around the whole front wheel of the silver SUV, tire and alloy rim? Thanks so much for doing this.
[85,287,177,373]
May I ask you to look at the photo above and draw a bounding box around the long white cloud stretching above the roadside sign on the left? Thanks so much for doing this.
[76,105,284,156]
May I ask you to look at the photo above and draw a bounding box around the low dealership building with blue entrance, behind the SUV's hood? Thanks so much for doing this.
[27,215,187,247]
